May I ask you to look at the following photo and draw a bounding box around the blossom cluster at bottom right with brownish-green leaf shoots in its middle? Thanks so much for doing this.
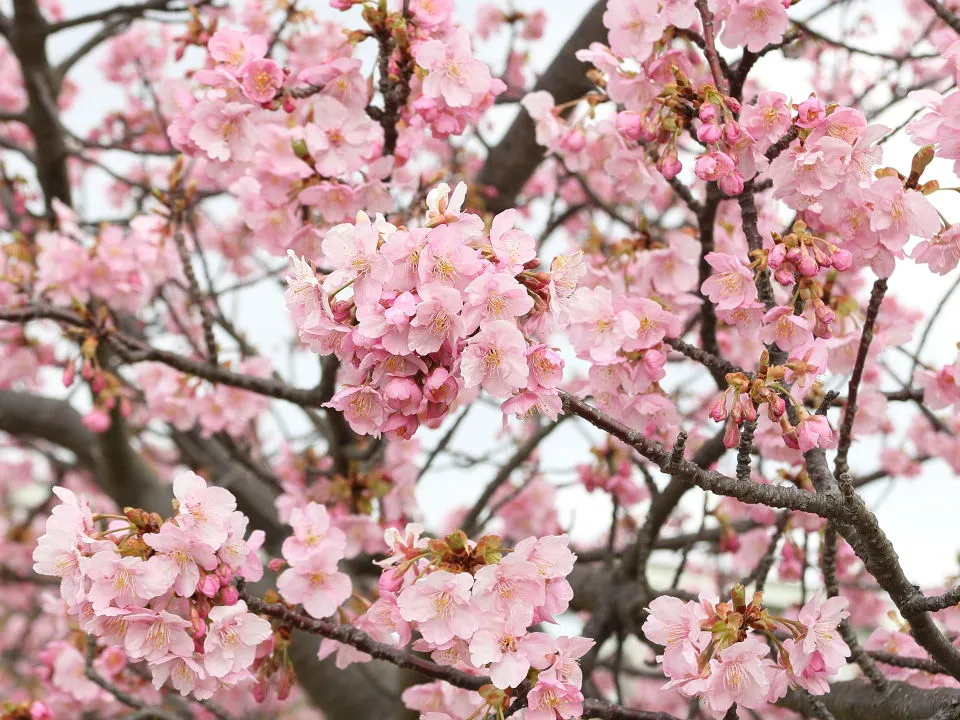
[643,585,850,718]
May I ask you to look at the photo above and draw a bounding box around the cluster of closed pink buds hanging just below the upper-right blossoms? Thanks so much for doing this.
[751,220,853,286]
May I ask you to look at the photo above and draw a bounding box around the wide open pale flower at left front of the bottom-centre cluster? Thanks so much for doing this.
[397,570,480,645]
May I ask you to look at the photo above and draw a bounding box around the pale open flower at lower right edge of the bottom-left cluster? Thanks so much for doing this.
[203,600,271,678]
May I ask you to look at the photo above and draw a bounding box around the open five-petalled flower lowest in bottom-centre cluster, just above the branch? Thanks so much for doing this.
[470,614,557,689]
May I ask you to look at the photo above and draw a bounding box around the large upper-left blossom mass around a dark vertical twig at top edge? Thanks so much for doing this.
[169,3,506,255]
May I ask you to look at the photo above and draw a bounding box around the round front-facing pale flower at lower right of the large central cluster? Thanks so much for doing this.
[460,320,529,397]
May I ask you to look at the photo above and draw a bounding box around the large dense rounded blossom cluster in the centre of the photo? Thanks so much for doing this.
[286,183,584,438]
